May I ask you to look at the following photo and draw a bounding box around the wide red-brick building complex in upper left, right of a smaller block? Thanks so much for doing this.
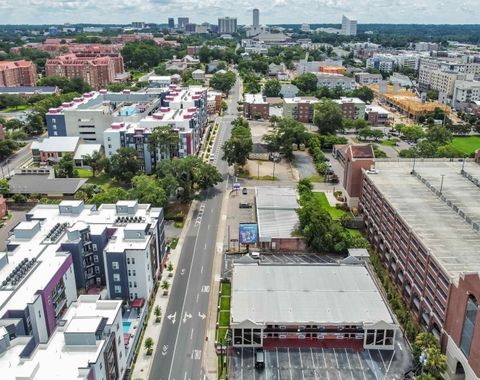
[45,54,118,89]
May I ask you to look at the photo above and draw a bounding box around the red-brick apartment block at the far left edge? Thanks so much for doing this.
[0,60,37,87]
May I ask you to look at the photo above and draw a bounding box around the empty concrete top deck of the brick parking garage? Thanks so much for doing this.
[366,160,480,279]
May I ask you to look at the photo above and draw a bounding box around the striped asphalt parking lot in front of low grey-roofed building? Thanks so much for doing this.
[229,346,411,380]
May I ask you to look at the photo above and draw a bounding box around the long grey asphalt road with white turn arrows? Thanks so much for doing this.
[150,75,240,380]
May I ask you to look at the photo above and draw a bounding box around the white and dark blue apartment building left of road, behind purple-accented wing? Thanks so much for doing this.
[23,201,166,302]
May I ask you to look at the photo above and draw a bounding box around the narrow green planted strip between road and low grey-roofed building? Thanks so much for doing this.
[215,281,232,379]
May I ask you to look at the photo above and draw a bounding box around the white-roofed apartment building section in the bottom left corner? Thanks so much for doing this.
[0,295,128,380]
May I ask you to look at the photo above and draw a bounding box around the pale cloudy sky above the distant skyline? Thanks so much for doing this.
[0,0,480,25]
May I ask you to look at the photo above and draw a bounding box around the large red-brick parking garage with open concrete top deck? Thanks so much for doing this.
[359,160,480,380]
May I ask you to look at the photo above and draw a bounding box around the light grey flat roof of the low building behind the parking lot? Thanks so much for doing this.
[231,263,394,325]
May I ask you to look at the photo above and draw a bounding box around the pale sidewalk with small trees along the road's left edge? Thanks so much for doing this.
[131,200,197,380]
